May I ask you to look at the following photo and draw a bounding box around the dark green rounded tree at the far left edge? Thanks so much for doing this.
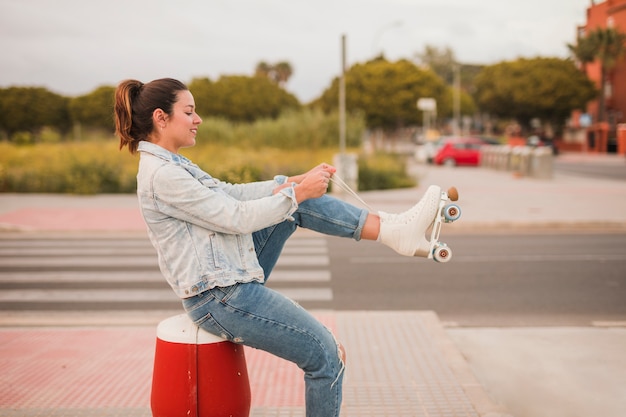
[0,87,71,138]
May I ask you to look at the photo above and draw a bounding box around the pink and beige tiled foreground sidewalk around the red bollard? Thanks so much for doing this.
[0,311,498,417]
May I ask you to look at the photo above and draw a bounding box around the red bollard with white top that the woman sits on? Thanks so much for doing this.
[150,314,251,417]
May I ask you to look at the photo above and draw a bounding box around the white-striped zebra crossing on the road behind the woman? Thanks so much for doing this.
[0,232,333,311]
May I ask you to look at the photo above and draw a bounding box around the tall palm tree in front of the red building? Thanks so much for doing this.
[567,28,626,121]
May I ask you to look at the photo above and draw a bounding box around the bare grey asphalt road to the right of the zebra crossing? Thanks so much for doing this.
[322,231,626,326]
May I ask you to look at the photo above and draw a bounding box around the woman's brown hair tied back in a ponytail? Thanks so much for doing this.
[115,78,188,153]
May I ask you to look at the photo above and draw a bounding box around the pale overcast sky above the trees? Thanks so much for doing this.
[0,0,591,102]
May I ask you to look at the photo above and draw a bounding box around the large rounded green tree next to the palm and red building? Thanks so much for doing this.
[475,58,597,128]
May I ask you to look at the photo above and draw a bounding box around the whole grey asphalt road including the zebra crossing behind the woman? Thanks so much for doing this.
[0,230,626,327]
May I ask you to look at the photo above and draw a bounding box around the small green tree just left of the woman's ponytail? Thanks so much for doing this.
[69,86,115,131]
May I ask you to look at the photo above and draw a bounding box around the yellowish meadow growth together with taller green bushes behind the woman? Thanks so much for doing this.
[0,111,415,194]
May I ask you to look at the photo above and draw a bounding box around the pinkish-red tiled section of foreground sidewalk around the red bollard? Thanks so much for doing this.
[0,327,316,410]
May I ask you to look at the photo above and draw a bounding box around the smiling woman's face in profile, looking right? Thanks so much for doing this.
[157,91,202,153]
